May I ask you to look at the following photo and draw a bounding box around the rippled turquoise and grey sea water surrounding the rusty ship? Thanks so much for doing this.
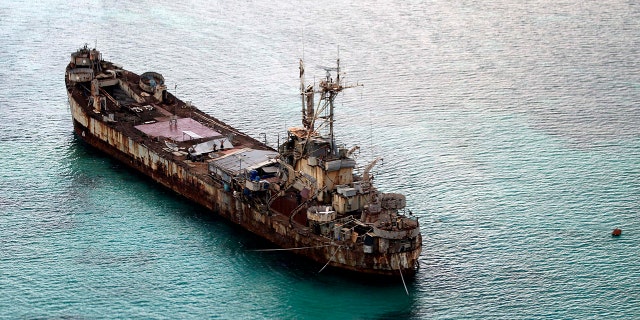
[0,0,640,319]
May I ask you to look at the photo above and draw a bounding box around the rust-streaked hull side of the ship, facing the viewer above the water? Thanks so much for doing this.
[69,93,422,277]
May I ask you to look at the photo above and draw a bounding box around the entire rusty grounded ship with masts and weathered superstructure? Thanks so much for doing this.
[65,45,422,280]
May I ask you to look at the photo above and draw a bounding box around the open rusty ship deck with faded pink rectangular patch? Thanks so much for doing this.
[70,64,275,183]
